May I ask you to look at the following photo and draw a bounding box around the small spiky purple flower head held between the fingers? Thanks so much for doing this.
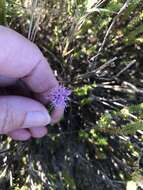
[48,86,71,107]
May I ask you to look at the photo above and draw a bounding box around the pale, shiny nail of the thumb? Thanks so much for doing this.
[23,111,51,128]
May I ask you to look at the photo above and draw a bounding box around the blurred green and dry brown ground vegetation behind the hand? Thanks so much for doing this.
[0,0,143,190]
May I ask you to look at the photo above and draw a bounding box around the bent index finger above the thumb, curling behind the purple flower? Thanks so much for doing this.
[0,26,64,122]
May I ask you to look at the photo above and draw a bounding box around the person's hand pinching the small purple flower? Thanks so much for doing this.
[0,26,64,140]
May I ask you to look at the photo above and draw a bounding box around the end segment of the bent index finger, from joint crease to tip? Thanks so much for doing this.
[22,57,64,123]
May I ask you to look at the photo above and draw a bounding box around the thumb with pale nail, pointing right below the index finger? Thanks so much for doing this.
[0,96,51,134]
